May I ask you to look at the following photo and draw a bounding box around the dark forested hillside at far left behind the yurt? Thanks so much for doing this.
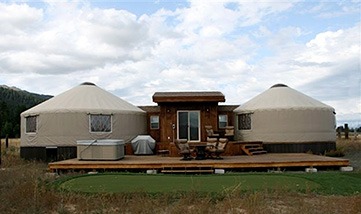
[0,85,52,138]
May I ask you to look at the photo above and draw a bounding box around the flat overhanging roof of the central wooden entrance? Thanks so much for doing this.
[153,91,226,103]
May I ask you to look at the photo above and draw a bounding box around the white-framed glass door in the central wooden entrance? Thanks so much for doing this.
[178,111,200,141]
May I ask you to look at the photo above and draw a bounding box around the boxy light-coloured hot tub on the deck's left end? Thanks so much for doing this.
[76,139,124,160]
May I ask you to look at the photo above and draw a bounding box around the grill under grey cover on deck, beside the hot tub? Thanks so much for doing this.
[131,135,155,155]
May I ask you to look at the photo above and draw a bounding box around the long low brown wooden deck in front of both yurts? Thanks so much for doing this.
[48,153,349,171]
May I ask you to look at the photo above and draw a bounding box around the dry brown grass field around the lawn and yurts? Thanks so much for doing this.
[0,136,361,214]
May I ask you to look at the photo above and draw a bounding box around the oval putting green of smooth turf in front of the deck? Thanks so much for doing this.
[61,174,319,193]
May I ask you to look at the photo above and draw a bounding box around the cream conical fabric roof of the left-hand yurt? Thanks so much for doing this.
[22,82,144,115]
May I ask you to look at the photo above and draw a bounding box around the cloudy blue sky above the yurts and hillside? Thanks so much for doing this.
[0,0,361,126]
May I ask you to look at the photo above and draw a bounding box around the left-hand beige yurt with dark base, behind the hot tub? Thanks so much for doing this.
[20,83,147,160]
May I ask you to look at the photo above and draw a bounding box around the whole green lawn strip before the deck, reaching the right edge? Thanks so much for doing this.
[59,172,361,195]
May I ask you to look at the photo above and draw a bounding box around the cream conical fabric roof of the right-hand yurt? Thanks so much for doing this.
[234,84,334,113]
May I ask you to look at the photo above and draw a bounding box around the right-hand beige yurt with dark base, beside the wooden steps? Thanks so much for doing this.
[234,84,336,154]
